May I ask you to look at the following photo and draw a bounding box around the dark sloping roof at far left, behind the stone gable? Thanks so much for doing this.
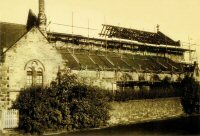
[0,22,27,54]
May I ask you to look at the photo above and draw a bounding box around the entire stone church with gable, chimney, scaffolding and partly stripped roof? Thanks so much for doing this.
[0,0,197,108]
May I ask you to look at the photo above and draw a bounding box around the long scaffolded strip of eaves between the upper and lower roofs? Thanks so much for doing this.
[47,32,194,55]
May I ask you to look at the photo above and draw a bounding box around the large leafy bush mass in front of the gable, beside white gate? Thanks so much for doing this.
[12,71,109,134]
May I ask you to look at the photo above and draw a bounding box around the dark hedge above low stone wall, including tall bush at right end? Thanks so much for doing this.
[104,76,200,114]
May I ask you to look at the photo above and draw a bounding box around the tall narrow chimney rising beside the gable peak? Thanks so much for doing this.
[38,0,47,35]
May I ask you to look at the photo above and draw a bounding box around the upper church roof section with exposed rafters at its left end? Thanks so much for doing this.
[100,24,180,46]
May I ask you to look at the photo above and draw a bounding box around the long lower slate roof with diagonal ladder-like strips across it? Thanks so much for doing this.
[58,48,192,73]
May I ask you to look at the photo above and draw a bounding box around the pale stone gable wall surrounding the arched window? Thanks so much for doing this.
[0,27,63,104]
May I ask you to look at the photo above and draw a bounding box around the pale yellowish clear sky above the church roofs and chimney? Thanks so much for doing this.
[0,0,200,58]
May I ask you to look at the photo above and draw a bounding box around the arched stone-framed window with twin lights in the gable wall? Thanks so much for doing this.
[25,60,44,86]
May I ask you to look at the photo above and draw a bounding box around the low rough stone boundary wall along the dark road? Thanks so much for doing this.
[108,98,184,126]
